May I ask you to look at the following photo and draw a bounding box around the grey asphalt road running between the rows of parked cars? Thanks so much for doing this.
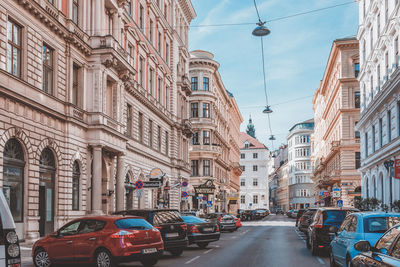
[22,215,329,267]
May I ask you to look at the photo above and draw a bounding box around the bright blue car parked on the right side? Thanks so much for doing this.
[330,212,400,266]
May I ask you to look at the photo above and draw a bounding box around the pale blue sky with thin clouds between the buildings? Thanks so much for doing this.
[189,0,358,150]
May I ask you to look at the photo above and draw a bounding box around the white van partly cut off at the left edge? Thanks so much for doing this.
[0,189,21,267]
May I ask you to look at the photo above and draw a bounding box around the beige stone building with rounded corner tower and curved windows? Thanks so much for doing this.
[187,50,243,212]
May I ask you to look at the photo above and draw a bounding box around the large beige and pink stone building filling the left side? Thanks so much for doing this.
[0,0,196,241]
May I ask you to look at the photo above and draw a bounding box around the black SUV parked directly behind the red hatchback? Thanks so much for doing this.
[115,209,188,256]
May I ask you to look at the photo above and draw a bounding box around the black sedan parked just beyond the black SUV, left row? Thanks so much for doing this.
[182,216,221,248]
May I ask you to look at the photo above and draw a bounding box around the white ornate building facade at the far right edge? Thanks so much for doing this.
[357,0,400,209]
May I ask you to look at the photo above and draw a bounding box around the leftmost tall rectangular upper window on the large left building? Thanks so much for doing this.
[7,20,22,77]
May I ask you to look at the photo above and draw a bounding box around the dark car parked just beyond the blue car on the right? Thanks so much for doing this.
[306,207,359,255]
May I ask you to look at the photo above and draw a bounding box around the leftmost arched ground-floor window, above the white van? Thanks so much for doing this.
[3,138,25,222]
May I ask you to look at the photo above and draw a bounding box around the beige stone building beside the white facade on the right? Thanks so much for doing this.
[311,38,360,206]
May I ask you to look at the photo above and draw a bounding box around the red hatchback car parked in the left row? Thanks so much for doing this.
[32,216,164,267]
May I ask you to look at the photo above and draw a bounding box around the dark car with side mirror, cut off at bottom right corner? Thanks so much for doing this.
[351,224,400,267]
